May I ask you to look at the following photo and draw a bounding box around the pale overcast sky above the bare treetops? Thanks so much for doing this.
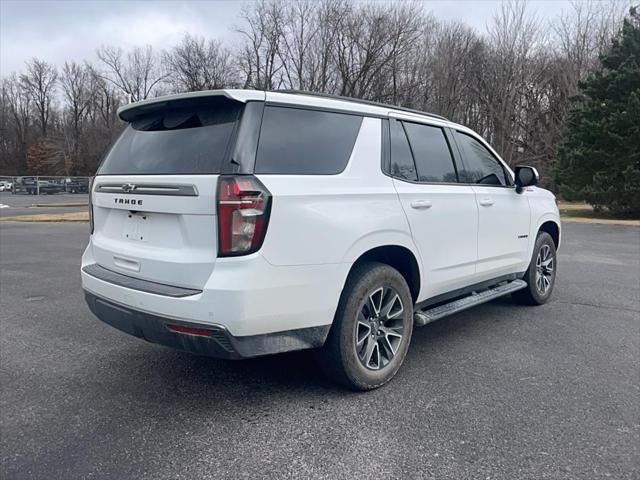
[0,0,569,75]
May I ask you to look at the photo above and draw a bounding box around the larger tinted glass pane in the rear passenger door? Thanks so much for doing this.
[404,122,458,183]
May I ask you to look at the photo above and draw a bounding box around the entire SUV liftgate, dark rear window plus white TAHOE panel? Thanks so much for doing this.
[92,98,242,288]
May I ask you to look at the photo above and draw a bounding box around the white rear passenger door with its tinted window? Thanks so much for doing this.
[390,119,478,300]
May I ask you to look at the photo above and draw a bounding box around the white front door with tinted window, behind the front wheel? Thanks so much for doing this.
[454,132,531,278]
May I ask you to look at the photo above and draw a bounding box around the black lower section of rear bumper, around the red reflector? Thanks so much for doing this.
[85,290,331,359]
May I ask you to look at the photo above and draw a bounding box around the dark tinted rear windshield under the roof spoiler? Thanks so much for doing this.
[98,99,242,175]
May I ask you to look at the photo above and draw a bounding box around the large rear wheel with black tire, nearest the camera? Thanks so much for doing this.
[317,262,413,391]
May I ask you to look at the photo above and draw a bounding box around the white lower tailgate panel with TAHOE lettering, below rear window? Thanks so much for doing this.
[92,175,218,289]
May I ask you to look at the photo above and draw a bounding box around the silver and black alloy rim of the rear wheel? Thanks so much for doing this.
[355,286,404,370]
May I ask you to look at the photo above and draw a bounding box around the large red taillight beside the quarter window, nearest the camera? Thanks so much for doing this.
[218,176,271,257]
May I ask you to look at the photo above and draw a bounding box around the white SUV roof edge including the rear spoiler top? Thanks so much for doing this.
[118,89,454,126]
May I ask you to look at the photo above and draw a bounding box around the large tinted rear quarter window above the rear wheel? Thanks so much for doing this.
[255,107,362,175]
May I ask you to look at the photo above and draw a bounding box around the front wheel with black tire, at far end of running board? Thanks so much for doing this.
[511,232,558,305]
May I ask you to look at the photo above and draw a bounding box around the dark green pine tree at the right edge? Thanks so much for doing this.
[556,8,640,216]
